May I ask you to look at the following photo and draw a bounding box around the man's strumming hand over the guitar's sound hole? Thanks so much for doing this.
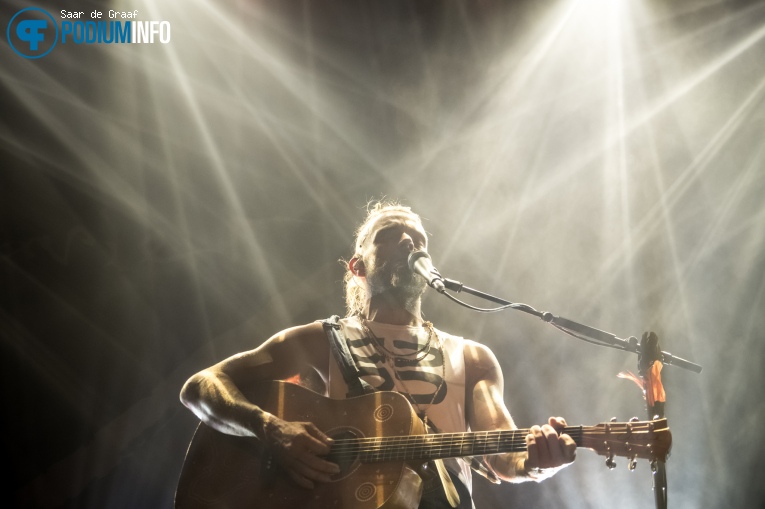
[261,414,340,489]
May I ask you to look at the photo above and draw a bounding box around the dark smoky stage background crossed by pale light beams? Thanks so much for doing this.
[0,0,765,509]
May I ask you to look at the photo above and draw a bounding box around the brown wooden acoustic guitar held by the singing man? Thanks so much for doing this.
[175,382,672,509]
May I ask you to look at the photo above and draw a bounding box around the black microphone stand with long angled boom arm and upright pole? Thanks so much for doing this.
[430,278,702,509]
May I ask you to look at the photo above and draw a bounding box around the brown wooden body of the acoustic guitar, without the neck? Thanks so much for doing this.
[175,382,425,509]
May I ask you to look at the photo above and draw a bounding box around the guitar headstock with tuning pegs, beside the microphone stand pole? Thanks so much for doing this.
[581,419,672,470]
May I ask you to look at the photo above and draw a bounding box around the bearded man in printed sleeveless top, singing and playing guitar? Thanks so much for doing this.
[181,203,576,509]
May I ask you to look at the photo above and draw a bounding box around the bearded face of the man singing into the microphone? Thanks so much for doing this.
[360,212,428,299]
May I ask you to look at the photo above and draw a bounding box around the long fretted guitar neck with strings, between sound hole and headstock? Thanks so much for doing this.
[329,426,590,463]
